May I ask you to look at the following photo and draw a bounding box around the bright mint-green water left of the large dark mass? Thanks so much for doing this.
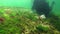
[0,0,32,8]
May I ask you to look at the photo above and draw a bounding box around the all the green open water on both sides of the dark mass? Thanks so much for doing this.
[0,0,60,15]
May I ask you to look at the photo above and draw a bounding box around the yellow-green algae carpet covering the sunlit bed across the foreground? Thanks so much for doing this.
[0,8,60,34]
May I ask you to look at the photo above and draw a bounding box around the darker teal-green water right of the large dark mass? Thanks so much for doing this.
[49,0,60,16]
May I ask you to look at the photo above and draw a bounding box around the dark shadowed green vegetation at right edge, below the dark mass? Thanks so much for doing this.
[49,14,60,31]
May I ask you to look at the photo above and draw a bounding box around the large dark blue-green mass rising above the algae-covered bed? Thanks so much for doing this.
[32,0,55,17]
